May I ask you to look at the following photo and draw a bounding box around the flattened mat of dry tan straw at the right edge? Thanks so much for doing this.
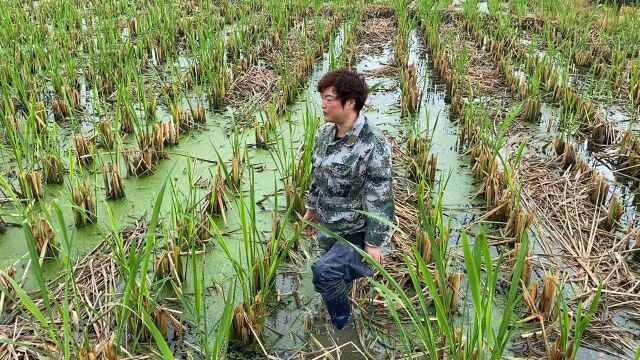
[519,157,640,351]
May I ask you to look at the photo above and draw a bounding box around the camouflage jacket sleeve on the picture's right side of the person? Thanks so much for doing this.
[362,140,395,246]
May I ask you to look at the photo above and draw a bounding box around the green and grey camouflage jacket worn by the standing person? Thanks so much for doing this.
[305,113,394,250]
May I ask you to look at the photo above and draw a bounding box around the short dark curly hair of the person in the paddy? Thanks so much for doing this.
[318,69,369,114]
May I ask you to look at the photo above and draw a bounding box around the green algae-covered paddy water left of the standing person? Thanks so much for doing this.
[0,17,341,360]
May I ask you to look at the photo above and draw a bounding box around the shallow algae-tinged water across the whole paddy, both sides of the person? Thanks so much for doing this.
[0,9,632,359]
